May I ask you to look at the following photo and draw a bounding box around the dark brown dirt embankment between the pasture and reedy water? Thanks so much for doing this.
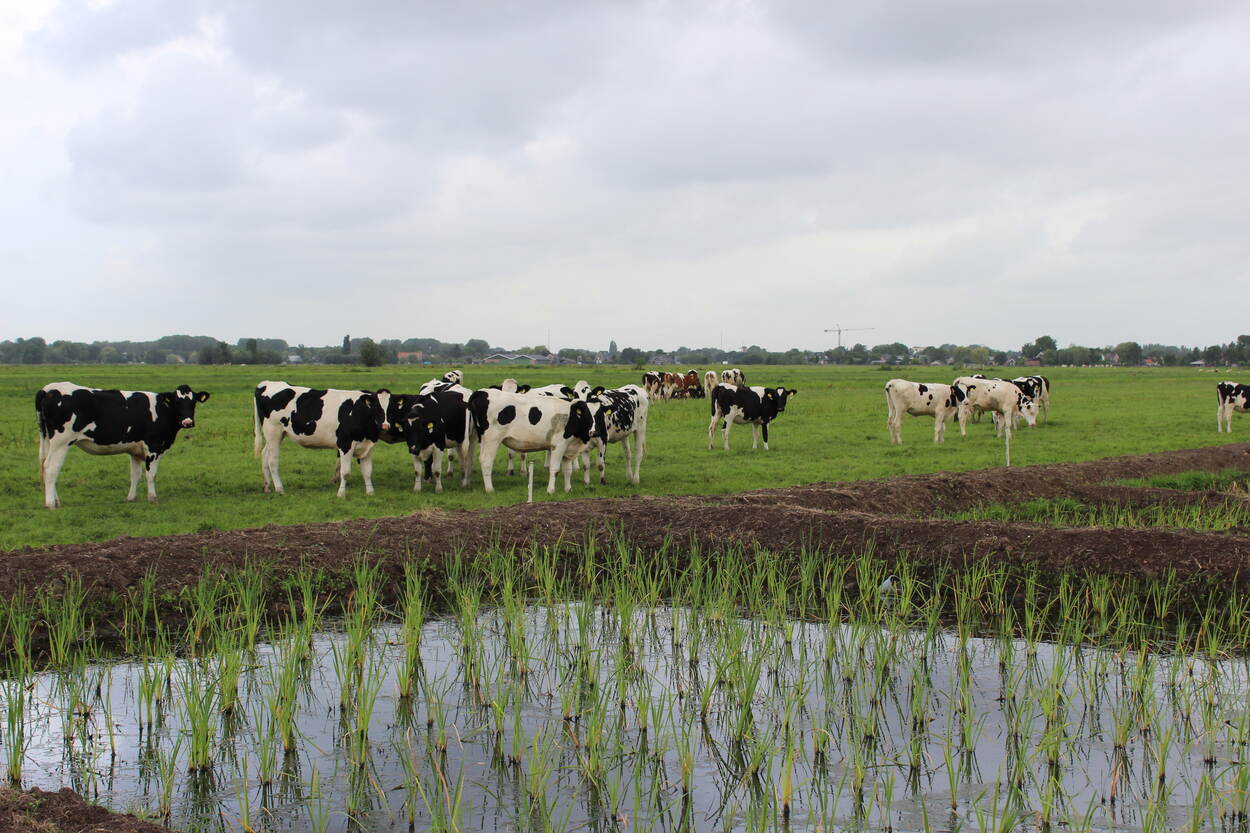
[7,444,1250,594]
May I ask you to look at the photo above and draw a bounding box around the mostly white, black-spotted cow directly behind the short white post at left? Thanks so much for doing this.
[469,389,596,494]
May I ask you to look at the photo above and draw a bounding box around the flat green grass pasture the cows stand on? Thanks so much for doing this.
[0,365,1235,549]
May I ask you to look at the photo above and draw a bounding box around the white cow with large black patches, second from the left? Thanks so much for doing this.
[253,380,391,498]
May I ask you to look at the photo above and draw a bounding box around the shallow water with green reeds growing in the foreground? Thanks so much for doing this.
[6,604,1250,830]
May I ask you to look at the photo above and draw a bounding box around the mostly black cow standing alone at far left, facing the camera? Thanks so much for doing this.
[35,381,209,509]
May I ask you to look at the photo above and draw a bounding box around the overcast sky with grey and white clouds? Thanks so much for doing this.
[0,0,1250,350]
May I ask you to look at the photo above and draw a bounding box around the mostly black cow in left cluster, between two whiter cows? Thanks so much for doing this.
[402,385,474,492]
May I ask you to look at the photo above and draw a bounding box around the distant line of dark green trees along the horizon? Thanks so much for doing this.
[0,335,1250,366]
